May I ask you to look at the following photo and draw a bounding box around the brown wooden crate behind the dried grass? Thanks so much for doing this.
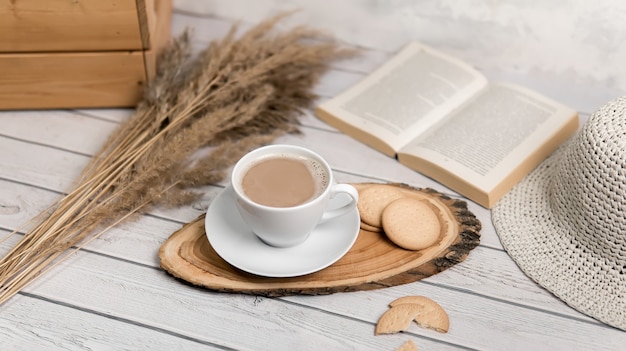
[0,0,172,110]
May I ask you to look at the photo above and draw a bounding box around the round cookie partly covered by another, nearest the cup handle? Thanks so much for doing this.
[357,184,403,228]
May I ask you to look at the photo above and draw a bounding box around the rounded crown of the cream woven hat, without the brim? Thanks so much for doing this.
[549,97,626,266]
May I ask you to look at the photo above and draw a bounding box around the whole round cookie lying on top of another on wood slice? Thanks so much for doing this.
[382,198,441,250]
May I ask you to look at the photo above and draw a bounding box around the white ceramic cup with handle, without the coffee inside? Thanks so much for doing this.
[231,145,359,247]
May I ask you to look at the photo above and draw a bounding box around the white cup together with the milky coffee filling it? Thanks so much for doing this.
[231,145,358,247]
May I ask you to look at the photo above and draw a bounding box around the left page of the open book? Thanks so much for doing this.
[320,43,487,150]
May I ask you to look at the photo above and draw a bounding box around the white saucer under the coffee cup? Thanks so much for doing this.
[204,187,361,277]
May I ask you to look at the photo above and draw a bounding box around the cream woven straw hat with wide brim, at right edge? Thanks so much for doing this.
[492,96,626,330]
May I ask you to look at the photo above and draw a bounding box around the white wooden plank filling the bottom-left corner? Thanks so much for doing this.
[0,292,223,351]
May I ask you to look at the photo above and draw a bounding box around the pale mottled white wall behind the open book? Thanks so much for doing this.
[174,0,626,112]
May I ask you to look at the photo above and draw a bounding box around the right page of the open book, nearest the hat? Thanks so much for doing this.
[402,84,576,192]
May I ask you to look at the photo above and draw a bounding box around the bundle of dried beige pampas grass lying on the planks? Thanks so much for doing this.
[0,15,353,304]
